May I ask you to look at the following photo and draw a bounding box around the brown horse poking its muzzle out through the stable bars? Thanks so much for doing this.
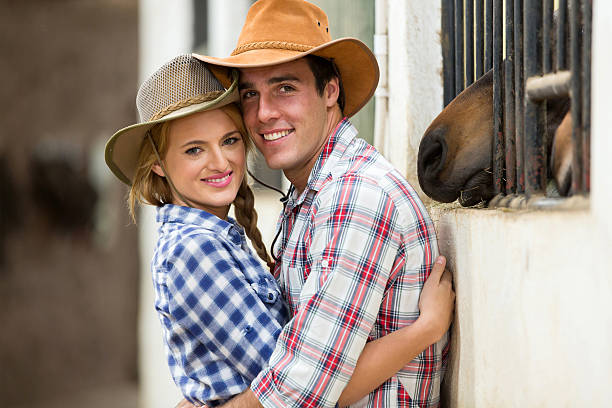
[417,70,572,207]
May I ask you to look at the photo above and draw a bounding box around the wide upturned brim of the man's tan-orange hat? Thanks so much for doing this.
[192,37,380,117]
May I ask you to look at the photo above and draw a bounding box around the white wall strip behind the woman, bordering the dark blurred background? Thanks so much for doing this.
[134,0,193,408]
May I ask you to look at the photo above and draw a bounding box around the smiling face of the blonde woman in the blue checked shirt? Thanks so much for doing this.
[153,109,246,219]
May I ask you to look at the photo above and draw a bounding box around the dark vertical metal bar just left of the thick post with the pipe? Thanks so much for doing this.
[514,0,525,194]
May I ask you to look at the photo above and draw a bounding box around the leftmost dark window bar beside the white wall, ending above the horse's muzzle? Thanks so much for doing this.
[442,0,456,106]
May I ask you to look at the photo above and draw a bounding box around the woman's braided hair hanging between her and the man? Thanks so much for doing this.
[234,177,274,271]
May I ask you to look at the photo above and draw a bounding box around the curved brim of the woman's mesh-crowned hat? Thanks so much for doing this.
[104,71,239,185]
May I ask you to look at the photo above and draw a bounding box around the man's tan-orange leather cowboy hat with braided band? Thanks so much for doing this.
[194,0,379,116]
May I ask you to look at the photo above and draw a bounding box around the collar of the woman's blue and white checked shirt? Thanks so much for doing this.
[157,204,244,244]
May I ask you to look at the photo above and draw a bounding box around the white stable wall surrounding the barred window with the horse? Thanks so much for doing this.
[384,0,612,407]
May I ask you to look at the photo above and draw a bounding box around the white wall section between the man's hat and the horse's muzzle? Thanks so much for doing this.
[384,0,443,198]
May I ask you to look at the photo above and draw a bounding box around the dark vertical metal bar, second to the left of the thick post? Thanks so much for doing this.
[504,0,516,194]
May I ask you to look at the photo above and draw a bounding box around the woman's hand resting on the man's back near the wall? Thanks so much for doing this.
[418,256,455,343]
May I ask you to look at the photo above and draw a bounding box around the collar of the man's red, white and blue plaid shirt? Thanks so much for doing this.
[290,117,357,205]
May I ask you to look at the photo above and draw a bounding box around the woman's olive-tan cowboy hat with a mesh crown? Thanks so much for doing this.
[105,54,239,185]
